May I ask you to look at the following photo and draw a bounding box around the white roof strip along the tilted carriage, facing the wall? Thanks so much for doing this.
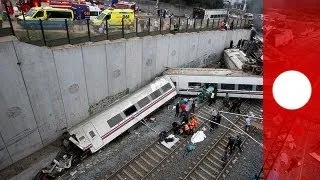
[68,76,169,131]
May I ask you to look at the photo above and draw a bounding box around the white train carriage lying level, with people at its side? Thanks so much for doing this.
[164,68,263,99]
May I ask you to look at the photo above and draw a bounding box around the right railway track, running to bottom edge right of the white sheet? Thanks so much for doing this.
[184,102,262,180]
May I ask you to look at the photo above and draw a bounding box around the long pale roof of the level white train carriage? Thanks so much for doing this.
[164,68,262,77]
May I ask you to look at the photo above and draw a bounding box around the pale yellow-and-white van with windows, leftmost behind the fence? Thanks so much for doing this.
[18,7,74,29]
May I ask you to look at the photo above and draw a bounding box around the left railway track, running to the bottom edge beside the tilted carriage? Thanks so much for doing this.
[106,99,222,180]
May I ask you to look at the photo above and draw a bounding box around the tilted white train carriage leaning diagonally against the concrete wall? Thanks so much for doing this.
[68,76,177,153]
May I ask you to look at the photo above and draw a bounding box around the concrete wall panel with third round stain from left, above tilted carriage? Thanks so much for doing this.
[106,40,127,95]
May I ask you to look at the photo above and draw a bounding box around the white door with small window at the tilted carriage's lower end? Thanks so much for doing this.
[83,123,103,150]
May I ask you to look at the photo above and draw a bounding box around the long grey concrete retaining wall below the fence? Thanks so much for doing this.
[0,30,250,169]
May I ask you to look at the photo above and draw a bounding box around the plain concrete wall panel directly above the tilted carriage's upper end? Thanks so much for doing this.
[156,35,170,74]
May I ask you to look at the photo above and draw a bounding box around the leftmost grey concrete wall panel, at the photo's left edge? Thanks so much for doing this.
[0,41,43,168]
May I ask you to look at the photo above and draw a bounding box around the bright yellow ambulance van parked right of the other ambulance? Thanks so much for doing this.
[91,8,134,26]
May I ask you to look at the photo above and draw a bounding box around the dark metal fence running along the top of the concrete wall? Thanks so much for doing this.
[0,7,251,47]
